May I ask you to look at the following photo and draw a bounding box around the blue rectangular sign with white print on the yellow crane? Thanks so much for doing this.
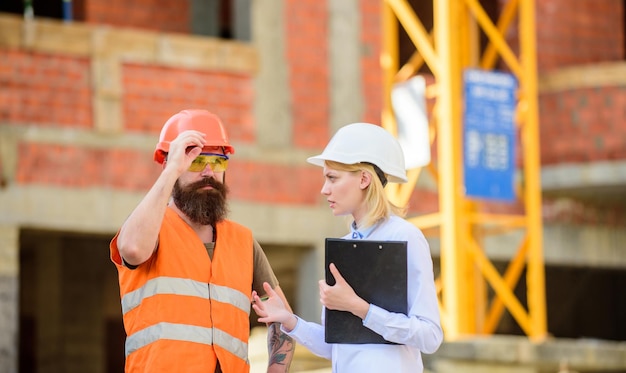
[463,69,518,201]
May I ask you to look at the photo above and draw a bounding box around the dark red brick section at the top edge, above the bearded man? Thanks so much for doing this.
[80,0,190,33]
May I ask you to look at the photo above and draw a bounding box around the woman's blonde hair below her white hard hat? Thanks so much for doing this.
[326,160,406,228]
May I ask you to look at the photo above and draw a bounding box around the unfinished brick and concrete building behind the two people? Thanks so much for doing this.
[0,0,626,373]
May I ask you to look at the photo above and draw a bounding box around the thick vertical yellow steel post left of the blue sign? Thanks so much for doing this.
[434,0,475,340]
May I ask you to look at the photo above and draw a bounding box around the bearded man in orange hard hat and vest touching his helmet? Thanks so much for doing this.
[110,110,295,373]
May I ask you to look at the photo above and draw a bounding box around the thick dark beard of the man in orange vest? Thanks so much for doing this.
[172,177,228,226]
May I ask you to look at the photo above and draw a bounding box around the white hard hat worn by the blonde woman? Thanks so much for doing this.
[307,123,407,183]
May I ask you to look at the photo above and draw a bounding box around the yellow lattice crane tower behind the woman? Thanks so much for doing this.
[381,0,547,340]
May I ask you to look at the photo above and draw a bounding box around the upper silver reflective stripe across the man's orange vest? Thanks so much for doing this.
[122,277,250,315]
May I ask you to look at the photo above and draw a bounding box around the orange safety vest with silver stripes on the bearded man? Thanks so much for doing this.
[110,208,253,373]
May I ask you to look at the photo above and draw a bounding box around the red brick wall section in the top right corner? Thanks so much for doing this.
[535,0,625,71]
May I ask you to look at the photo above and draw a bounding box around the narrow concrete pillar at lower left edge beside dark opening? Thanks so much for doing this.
[0,226,19,373]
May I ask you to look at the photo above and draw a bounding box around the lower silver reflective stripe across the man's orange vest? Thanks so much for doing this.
[126,322,248,363]
